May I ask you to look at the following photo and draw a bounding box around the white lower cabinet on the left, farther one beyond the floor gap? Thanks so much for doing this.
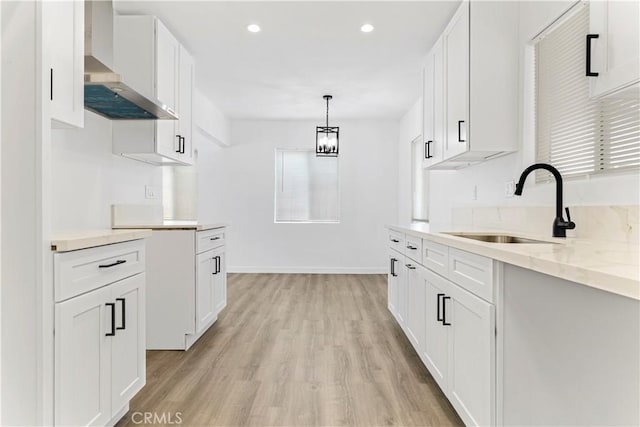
[147,227,227,350]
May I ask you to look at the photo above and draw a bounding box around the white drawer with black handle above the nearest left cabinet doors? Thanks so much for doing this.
[53,240,145,301]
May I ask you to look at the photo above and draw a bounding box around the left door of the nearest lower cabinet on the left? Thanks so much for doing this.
[54,287,113,426]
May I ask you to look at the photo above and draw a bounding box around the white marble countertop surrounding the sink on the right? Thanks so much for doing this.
[387,224,640,300]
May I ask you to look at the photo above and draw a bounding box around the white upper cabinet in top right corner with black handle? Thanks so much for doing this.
[585,0,640,97]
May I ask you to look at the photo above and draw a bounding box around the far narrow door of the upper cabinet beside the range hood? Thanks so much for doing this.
[178,46,195,164]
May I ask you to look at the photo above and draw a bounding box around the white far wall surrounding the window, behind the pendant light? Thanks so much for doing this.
[198,120,399,272]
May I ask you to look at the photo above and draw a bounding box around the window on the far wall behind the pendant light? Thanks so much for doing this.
[275,150,340,222]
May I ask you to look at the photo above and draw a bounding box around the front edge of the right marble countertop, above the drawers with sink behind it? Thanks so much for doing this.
[385,225,640,300]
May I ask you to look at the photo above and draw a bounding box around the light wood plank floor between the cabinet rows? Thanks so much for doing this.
[118,274,463,426]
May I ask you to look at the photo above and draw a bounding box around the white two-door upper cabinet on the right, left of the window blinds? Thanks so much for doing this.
[423,1,519,169]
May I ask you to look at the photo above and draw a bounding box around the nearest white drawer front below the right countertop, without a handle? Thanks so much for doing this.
[448,248,494,302]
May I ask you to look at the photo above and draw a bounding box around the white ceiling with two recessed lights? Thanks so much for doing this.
[114,0,459,123]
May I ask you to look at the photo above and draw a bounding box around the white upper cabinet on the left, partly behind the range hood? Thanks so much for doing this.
[113,16,194,165]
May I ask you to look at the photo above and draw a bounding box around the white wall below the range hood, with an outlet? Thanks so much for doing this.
[51,111,162,231]
